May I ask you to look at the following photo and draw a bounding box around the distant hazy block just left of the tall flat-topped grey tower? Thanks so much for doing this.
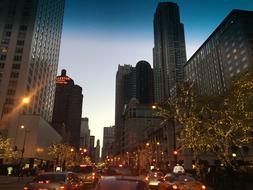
[102,126,115,161]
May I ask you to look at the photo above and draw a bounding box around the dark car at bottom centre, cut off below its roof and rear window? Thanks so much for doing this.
[95,176,150,190]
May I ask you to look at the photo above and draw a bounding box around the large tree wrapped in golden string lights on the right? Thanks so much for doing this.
[159,73,253,166]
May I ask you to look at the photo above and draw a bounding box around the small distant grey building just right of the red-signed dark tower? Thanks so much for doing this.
[80,117,90,150]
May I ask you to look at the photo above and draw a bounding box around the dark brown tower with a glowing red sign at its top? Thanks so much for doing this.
[52,69,83,149]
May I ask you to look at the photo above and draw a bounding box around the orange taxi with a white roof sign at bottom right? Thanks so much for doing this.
[158,173,207,190]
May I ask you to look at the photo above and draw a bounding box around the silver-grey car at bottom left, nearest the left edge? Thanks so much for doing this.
[23,172,82,190]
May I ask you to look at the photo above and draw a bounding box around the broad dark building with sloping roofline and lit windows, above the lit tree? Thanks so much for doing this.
[185,10,253,95]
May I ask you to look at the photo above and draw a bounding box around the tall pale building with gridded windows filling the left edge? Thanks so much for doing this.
[0,0,65,163]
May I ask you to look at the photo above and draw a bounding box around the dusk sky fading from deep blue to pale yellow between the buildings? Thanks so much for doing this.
[58,0,253,144]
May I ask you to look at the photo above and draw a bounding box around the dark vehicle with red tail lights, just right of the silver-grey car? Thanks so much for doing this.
[72,164,100,185]
